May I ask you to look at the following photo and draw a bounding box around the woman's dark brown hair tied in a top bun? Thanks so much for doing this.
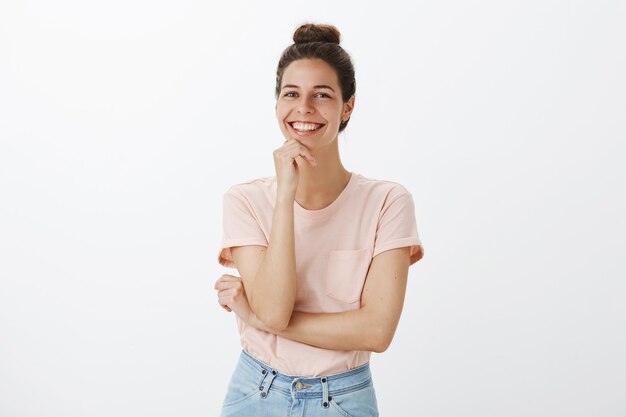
[275,23,356,132]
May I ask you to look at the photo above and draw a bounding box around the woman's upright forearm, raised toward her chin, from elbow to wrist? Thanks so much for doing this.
[250,197,296,329]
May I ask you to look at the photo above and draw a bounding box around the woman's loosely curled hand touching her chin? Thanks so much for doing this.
[274,139,317,198]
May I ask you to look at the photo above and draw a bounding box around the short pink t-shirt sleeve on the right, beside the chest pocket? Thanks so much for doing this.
[372,192,424,265]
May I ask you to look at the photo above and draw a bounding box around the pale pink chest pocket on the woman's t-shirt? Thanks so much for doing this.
[325,248,372,303]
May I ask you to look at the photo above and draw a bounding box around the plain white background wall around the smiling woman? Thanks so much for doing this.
[0,0,626,417]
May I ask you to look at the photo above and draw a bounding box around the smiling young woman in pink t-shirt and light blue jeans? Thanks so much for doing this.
[215,24,423,417]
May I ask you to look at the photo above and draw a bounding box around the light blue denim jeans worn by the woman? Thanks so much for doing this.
[220,350,378,417]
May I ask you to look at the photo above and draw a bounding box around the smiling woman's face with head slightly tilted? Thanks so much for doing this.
[276,59,354,150]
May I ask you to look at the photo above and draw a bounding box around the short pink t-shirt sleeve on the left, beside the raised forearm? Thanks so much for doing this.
[217,188,268,268]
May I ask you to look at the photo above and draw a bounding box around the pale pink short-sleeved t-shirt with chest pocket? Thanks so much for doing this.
[218,172,423,377]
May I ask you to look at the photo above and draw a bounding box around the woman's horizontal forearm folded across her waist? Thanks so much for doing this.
[251,308,388,352]
